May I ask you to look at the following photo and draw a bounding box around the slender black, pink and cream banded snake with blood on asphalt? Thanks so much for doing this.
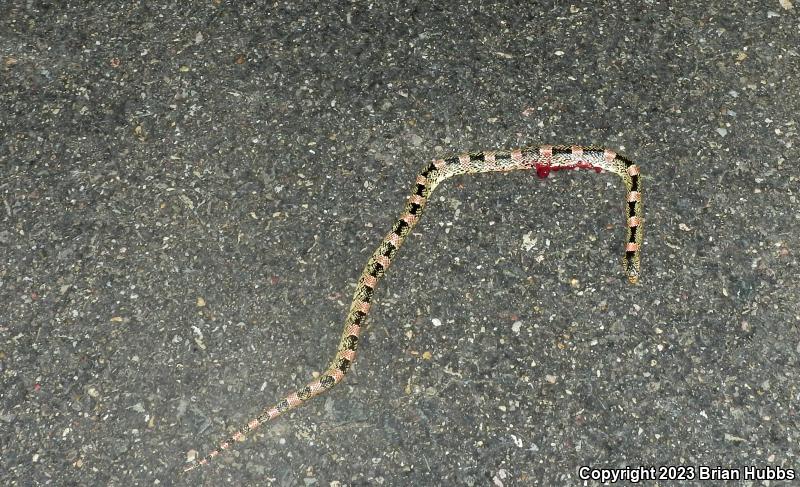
[184,145,643,472]
